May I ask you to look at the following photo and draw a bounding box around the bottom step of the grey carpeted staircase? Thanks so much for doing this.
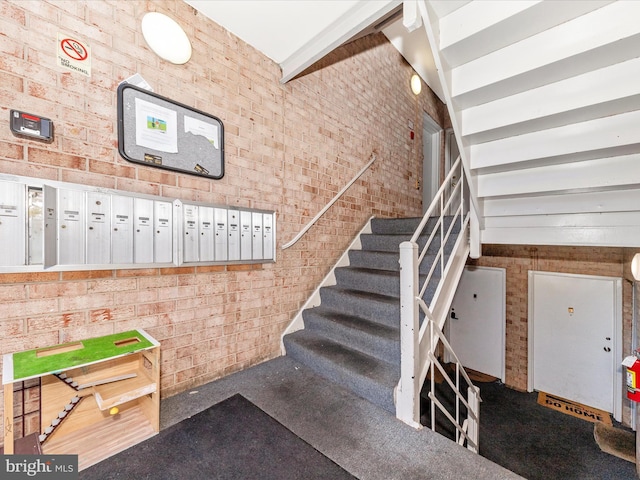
[284,330,400,415]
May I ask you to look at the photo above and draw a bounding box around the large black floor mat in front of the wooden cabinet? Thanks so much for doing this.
[80,394,355,480]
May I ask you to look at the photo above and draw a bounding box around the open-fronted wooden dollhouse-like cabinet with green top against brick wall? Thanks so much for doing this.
[3,329,160,470]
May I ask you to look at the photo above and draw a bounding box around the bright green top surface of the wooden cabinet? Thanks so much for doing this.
[13,330,153,381]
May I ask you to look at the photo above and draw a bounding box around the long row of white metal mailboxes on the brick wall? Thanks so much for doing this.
[0,181,275,268]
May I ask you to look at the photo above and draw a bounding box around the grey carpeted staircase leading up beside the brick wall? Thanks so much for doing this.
[283,217,459,415]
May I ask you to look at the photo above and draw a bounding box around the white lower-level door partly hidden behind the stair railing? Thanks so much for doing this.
[449,266,506,381]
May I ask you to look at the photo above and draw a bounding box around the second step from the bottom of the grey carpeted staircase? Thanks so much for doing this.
[303,306,400,364]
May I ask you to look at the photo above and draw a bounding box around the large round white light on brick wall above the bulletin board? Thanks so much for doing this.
[142,12,191,65]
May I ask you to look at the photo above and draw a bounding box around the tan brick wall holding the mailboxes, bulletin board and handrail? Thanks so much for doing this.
[0,0,446,432]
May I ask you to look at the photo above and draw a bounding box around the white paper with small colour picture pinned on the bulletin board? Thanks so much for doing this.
[136,98,178,153]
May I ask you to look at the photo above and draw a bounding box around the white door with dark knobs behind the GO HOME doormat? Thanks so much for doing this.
[529,272,622,418]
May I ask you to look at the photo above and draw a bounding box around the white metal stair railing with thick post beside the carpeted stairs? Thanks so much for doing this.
[396,157,481,453]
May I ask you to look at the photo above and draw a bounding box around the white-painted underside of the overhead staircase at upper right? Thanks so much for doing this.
[418,0,640,251]
